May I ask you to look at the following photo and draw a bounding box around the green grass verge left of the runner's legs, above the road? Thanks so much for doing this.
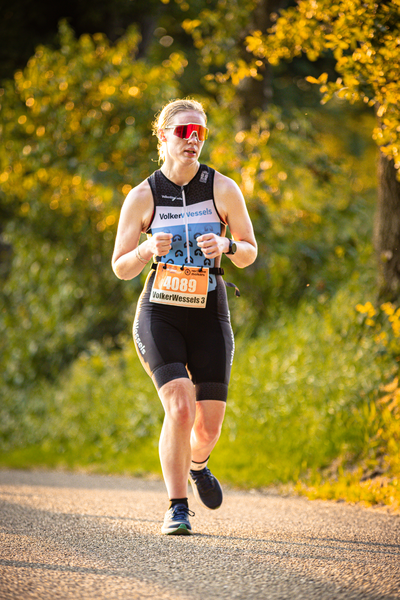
[0,343,162,475]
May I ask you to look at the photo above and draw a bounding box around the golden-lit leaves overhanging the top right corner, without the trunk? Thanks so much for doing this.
[247,0,400,168]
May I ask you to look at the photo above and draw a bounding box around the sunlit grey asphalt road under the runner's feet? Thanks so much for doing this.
[0,470,400,600]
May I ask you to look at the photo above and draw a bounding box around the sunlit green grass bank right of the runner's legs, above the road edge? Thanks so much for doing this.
[215,284,389,486]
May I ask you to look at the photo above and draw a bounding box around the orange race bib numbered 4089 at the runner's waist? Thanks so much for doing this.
[150,262,208,308]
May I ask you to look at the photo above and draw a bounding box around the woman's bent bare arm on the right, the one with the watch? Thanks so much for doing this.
[197,172,257,268]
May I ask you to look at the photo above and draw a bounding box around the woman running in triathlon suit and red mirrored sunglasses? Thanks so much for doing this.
[112,99,257,535]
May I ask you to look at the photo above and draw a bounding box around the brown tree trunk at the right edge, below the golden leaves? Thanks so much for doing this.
[374,152,400,302]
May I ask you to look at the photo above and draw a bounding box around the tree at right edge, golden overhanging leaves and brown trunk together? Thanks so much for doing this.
[242,0,400,300]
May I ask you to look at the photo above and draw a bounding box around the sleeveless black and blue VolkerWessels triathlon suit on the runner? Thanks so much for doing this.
[133,165,234,402]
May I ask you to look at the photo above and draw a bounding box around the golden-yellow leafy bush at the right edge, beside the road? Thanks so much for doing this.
[295,301,400,510]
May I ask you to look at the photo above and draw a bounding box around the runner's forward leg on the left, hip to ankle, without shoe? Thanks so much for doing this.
[133,288,196,499]
